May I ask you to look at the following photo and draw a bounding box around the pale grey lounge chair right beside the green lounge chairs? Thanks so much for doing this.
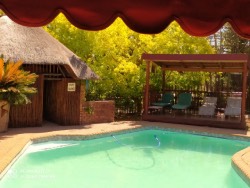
[198,97,217,116]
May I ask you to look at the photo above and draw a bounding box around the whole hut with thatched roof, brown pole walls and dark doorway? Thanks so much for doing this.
[0,16,98,127]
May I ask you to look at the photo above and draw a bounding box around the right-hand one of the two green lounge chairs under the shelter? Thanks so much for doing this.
[172,93,192,110]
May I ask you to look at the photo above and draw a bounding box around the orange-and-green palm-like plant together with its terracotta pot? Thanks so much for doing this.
[0,57,37,132]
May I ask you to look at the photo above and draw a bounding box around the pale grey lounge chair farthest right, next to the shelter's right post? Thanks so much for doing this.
[224,97,242,116]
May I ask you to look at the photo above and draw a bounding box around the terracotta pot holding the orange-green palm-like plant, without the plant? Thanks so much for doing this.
[0,101,10,132]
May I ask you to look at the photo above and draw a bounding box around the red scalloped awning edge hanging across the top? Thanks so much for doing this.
[0,0,250,38]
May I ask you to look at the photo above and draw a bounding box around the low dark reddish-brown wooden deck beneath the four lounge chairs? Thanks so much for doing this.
[142,112,247,129]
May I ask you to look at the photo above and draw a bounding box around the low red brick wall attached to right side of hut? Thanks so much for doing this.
[80,100,115,124]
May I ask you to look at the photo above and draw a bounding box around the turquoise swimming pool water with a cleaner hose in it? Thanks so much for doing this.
[0,130,250,188]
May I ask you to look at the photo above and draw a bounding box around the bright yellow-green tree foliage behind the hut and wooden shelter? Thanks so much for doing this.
[46,14,214,114]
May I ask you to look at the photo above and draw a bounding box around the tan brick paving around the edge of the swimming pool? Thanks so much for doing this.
[0,121,250,185]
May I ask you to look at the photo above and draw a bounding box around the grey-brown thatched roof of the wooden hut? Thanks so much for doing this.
[0,16,98,79]
